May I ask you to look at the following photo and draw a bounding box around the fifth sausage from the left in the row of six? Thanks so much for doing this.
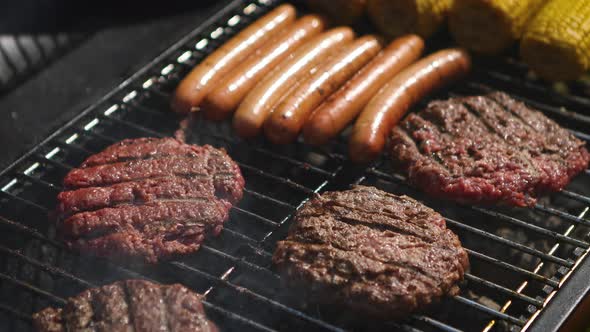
[303,35,424,145]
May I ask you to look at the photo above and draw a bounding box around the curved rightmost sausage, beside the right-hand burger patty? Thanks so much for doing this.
[348,49,471,162]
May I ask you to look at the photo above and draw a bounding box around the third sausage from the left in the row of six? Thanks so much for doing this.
[233,27,354,138]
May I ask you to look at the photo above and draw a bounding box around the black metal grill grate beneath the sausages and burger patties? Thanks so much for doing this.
[0,0,590,331]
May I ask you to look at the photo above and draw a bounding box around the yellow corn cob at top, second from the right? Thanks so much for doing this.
[449,0,545,54]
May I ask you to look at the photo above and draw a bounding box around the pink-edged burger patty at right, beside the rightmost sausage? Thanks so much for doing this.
[391,92,590,206]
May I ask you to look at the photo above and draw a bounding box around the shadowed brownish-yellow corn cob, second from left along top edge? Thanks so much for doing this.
[367,0,452,38]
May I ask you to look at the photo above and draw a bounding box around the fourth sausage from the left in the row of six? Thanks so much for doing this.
[264,36,381,144]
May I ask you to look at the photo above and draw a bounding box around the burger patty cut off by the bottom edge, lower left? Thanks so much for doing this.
[33,280,218,332]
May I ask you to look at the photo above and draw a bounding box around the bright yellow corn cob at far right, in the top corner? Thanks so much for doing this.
[520,0,590,81]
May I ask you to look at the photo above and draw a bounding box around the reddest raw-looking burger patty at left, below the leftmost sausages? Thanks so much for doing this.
[57,138,244,263]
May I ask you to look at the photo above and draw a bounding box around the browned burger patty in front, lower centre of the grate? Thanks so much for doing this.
[273,186,469,319]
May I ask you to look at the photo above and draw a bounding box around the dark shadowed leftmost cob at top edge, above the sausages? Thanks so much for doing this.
[307,0,367,24]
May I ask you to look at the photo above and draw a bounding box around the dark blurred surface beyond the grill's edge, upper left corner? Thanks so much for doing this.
[0,0,228,168]
